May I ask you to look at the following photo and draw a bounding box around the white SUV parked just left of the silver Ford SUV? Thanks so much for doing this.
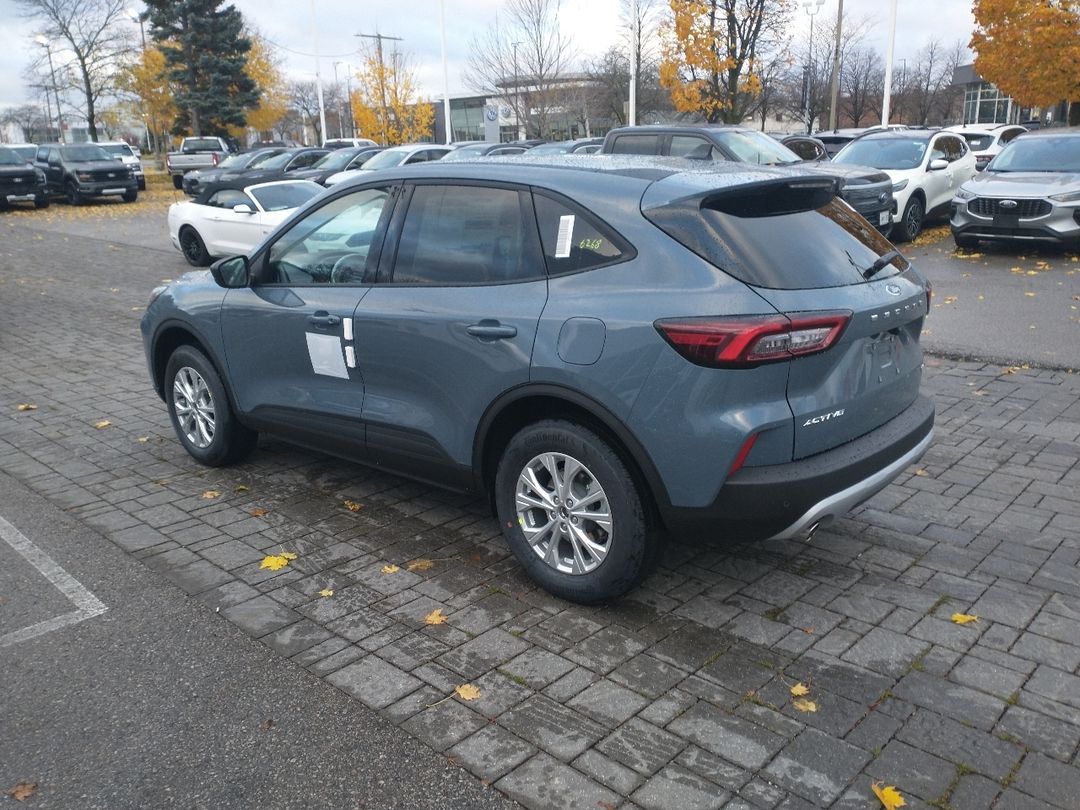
[833,130,975,242]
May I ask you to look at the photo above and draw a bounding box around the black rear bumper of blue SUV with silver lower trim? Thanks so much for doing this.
[662,396,934,540]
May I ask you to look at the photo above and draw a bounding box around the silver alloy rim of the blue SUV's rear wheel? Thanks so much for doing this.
[514,453,613,575]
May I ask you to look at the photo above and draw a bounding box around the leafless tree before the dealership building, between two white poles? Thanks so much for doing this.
[465,0,570,137]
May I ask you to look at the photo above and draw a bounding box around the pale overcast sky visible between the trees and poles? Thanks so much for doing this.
[0,0,973,113]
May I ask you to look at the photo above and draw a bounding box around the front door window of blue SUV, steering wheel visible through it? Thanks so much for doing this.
[261,187,392,285]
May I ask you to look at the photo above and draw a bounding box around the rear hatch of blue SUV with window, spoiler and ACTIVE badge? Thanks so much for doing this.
[642,173,929,465]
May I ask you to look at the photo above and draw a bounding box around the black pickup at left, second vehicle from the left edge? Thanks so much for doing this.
[37,144,138,205]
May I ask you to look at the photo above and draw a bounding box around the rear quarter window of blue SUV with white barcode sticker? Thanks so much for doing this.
[532,194,630,275]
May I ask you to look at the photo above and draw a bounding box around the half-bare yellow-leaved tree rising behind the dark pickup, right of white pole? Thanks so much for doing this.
[660,0,794,123]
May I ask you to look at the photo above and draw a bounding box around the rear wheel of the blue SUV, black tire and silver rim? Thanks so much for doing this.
[495,420,660,605]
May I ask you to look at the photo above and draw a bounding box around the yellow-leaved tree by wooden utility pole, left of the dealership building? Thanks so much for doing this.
[351,46,435,146]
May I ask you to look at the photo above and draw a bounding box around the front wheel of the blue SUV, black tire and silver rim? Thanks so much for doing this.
[165,346,259,467]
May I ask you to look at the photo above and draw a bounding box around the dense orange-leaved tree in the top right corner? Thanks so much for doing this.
[970,0,1080,117]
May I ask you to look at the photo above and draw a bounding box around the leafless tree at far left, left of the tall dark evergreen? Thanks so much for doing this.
[18,0,134,140]
